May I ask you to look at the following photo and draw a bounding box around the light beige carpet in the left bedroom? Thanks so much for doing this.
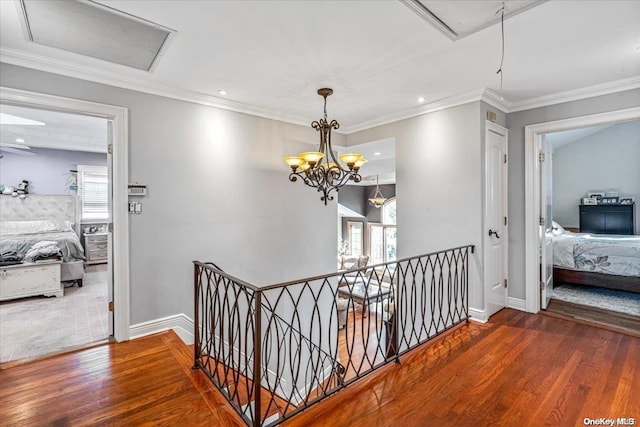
[0,265,109,363]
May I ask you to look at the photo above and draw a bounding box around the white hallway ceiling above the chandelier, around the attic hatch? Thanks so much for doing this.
[0,0,640,133]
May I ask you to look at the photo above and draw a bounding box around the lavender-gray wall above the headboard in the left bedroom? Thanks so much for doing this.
[0,148,107,194]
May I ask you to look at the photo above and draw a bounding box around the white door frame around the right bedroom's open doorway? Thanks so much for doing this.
[524,107,640,313]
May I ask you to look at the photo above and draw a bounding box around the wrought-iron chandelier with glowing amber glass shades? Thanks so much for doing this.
[284,88,367,205]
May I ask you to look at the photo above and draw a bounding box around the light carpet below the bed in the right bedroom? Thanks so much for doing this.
[551,285,640,316]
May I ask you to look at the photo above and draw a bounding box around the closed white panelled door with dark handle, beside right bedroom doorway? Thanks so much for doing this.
[484,121,508,316]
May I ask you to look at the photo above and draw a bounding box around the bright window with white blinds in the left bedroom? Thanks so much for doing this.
[78,165,109,221]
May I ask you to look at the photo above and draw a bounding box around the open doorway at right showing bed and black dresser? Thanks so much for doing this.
[541,120,640,333]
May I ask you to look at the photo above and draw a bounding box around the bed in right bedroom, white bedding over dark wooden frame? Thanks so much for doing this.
[552,223,640,293]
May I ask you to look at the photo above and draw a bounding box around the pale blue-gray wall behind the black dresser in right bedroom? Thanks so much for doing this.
[553,121,640,234]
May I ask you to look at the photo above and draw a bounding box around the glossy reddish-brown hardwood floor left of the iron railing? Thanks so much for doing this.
[0,332,243,426]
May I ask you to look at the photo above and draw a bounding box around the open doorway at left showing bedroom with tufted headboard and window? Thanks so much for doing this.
[0,103,113,363]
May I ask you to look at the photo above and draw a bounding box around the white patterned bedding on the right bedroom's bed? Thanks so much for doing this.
[553,231,640,277]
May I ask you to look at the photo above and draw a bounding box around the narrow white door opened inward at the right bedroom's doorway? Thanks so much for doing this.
[538,135,553,309]
